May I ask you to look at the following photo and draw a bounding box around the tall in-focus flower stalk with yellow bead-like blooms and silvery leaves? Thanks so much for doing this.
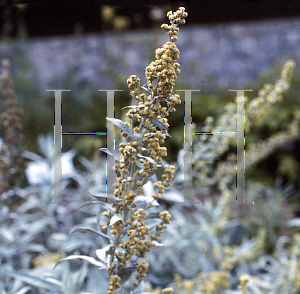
[102,7,187,294]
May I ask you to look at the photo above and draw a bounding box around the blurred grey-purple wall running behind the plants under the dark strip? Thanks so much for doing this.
[0,18,300,90]
